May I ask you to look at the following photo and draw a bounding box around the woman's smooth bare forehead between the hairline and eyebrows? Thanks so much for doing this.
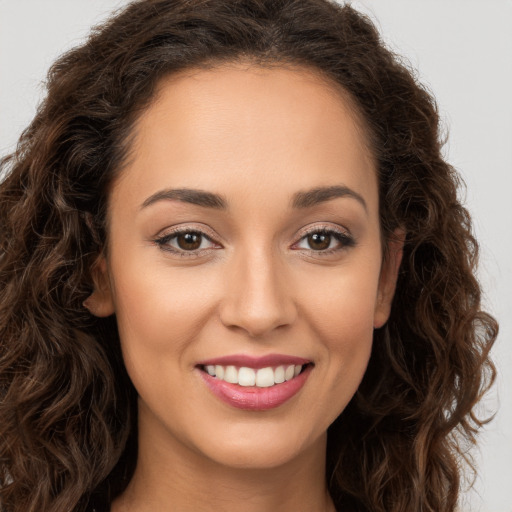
[111,64,376,216]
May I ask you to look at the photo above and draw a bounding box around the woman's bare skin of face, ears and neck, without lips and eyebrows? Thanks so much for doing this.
[86,64,401,512]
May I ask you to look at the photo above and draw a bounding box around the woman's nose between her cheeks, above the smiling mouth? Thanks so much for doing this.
[220,249,297,338]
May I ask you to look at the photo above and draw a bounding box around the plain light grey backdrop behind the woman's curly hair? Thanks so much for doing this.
[0,0,512,512]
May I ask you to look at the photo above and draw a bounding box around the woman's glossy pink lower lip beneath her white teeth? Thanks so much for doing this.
[198,365,312,411]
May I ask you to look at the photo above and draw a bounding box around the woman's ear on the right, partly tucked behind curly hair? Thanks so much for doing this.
[373,228,405,329]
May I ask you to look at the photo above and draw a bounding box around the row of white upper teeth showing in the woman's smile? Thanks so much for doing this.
[204,364,303,388]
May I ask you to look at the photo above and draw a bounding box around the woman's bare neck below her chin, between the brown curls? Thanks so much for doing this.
[112,408,335,512]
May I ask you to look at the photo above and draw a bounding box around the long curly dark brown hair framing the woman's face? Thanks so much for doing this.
[0,0,497,512]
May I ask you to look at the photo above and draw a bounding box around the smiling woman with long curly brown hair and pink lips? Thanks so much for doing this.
[0,0,497,512]
